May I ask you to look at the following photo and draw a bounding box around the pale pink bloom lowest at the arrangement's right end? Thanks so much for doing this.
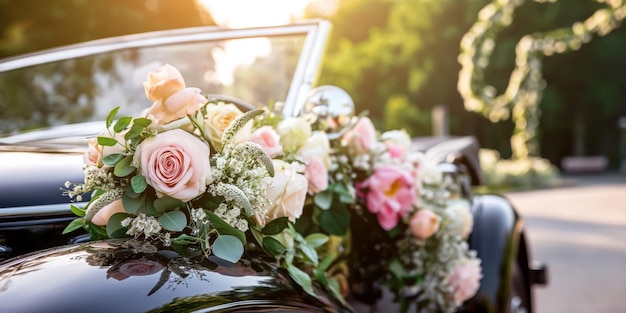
[446,259,482,305]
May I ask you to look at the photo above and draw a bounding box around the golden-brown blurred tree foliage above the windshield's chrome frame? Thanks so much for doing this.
[0,0,215,58]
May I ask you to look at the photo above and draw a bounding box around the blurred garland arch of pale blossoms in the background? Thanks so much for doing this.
[457,0,626,159]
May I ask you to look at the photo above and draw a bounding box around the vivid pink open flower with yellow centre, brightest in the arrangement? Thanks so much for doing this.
[357,166,415,230]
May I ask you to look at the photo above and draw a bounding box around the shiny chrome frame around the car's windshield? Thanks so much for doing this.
[0,20,330,116]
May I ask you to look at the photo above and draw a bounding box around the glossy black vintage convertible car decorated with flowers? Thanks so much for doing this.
[0,21,546,313]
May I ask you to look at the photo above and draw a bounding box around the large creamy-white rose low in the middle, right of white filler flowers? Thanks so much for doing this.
[257,160,308,226]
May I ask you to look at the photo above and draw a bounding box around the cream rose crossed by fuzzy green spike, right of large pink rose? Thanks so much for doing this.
[200,102,252,151]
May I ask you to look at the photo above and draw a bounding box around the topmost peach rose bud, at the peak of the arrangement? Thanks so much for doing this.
[143,64,185,102]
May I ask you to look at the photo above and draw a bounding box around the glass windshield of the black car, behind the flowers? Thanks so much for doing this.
[0,20,330,143]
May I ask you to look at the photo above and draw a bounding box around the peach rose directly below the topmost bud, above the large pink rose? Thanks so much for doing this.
[148,88,207,124]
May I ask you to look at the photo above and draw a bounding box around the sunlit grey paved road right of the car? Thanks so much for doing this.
[507,174,626,313]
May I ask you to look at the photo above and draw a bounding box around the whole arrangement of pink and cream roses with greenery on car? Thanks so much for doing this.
[65,65,481,312]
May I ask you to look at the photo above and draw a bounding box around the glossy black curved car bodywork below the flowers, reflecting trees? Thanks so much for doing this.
[0,239,350,313]
